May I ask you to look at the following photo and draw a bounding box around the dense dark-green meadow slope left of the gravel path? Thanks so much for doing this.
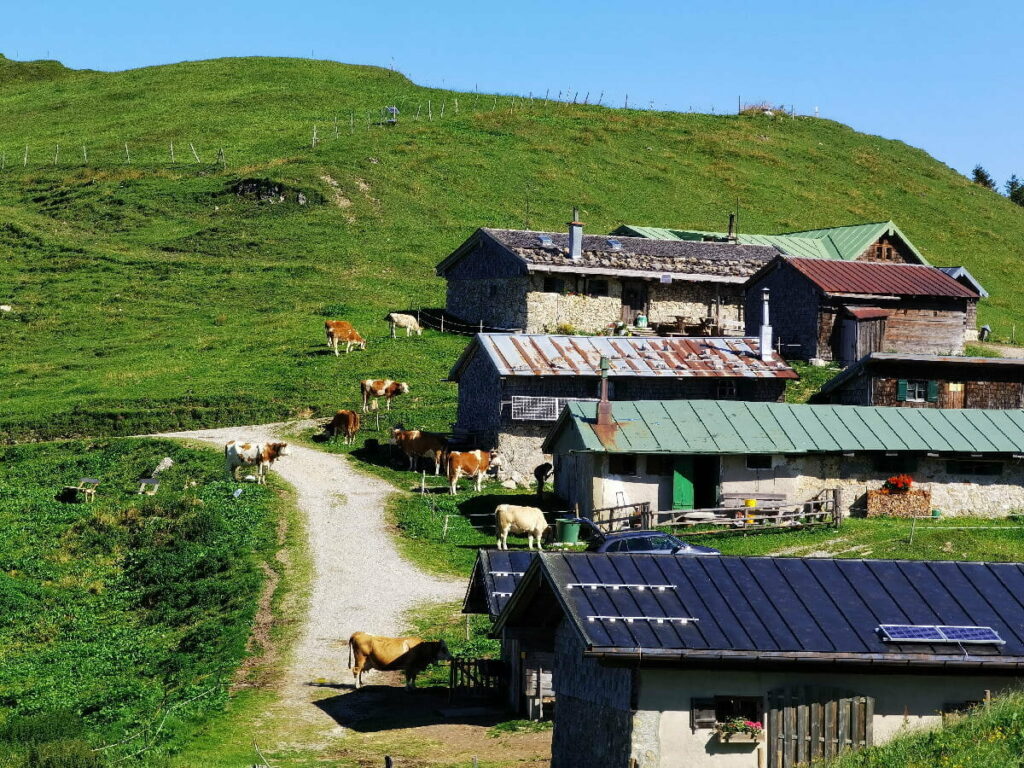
[0,439,285,768]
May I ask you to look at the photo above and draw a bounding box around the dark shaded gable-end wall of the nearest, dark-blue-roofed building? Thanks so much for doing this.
[551,620,634,768]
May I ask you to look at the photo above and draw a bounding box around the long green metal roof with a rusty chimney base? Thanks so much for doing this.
[544,400,1024,454]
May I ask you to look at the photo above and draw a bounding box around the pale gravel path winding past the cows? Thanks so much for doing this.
[159,424,466,720]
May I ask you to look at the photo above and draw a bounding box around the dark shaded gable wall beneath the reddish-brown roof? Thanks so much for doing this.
[744,265,831,360]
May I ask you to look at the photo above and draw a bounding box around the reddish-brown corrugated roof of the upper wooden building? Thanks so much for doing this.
[785,257,978,299]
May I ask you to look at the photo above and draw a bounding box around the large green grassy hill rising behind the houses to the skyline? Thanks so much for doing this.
[0,58,1024,438]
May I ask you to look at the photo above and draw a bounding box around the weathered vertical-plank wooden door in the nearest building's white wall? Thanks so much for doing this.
[767,686,874,768]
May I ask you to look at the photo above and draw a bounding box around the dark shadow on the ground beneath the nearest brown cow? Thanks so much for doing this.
[315,684,508,733]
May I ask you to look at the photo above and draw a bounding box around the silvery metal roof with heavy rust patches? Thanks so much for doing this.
[449,334,800,381]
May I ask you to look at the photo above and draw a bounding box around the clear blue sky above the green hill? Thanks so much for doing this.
[0,0,1024,186]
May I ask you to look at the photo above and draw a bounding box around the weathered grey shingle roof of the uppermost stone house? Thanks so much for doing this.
[437,227,781,283]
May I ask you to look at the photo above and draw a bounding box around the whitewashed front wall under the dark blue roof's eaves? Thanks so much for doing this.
[632,670,1022,768]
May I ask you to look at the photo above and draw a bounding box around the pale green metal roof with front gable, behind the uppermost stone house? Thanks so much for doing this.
[613,221,928,264]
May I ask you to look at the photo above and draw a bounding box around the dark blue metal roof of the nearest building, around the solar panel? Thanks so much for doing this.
[496,553,1024,673]
